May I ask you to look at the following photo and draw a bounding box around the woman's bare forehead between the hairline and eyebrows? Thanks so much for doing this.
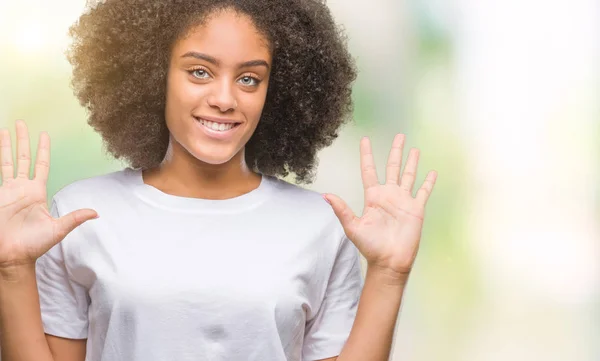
[173,10,271,64]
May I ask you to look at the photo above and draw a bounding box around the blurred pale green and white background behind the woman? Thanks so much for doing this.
[0,0,600,361]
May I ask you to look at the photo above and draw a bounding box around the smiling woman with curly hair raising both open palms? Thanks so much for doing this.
[0,0,435,361]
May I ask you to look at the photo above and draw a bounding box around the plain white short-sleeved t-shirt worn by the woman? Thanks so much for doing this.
[36,168,364,361]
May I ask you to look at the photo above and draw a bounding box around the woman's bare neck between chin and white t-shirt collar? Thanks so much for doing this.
[142,139,261,199]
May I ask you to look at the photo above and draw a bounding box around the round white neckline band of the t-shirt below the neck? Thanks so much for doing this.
[125,167,275,213]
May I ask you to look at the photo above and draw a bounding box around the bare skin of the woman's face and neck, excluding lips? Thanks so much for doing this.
[143,11,272,199]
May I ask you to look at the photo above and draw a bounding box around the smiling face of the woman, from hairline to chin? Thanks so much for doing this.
[165,11,272,165]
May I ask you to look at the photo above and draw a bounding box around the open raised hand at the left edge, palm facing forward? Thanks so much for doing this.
[0,120,97,270]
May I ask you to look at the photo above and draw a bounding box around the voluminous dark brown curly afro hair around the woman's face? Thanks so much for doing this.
[67,0,356,183]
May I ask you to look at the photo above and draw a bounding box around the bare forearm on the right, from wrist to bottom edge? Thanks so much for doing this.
[337,267,406,361]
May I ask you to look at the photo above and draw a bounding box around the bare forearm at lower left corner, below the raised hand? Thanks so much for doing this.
[0,265,53,361]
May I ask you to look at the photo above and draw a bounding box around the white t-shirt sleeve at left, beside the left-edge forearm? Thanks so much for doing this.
[36,199,88,339]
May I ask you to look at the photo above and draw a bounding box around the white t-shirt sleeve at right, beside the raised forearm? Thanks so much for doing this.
[302,231,364,361]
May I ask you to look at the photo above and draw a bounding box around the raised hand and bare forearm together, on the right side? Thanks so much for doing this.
[324,134,437,361]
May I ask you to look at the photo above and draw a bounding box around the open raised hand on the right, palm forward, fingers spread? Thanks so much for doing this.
[323,134,437,281]
